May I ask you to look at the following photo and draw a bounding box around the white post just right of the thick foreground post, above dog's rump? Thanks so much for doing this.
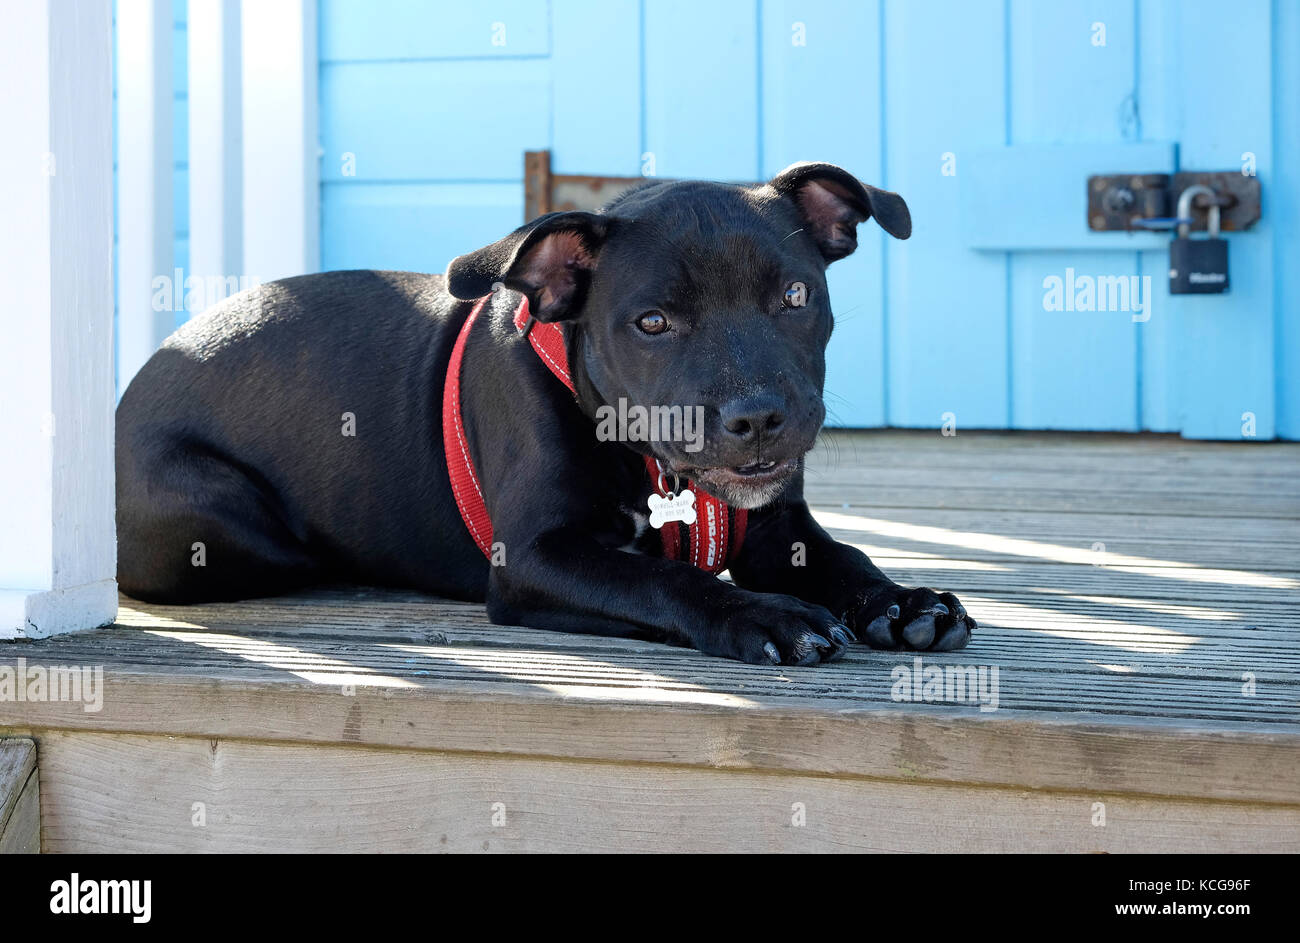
[117,0,174,390]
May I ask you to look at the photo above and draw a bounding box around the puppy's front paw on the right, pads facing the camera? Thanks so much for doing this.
[848,587,975,652]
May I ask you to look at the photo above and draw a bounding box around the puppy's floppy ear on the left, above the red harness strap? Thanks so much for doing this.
[447,213,610,321]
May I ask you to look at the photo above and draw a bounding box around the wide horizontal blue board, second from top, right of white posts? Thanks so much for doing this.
[320,60,551,182]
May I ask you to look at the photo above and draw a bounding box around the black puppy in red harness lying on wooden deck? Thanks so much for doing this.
[117,164,975,665]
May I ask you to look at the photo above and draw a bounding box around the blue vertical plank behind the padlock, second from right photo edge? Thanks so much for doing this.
[1170,0,1274,440]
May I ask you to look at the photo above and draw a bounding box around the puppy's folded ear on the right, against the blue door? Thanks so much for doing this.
[770,161,911,261]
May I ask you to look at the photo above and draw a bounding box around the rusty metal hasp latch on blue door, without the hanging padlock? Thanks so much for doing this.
[1088,170,1260,233]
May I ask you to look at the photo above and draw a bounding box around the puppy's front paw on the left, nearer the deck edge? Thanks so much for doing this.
[699,593,855,667]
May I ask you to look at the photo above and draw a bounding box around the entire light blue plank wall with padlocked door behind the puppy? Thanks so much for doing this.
[320,0,1300,440]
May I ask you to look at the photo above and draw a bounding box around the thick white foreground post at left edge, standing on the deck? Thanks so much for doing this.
[0,0,117,639]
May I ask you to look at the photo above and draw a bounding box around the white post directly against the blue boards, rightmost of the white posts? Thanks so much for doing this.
[243,0,320,282]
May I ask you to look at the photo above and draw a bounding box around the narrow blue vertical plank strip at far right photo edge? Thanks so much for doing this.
[1265,0,1300,438]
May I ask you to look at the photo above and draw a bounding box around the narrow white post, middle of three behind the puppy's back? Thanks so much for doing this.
[187,0,244,304]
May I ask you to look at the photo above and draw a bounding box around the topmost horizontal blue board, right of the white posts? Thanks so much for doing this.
[319,0,550,62]
